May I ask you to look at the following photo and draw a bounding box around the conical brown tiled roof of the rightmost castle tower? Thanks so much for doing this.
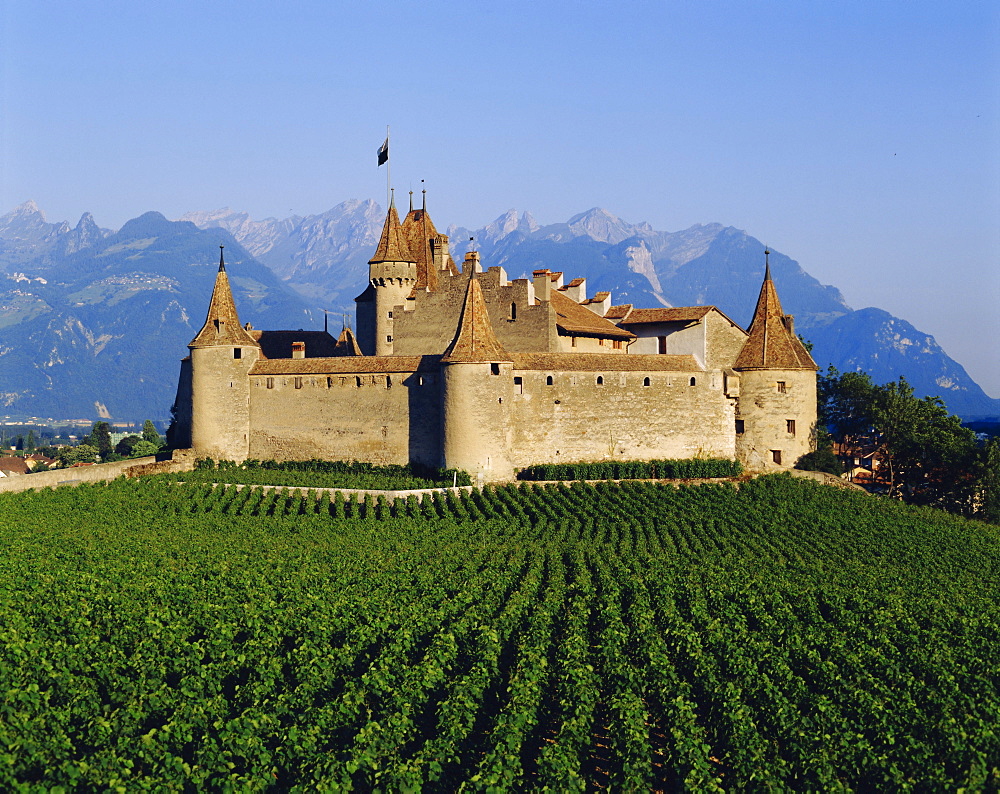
[733,251,817,370]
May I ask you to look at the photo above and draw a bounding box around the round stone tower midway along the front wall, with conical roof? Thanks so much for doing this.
[441,251,514,483]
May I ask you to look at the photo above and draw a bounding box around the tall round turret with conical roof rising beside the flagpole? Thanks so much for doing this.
[355,193,417,356]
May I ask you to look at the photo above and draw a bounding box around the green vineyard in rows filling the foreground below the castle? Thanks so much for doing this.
[0,476,1000,791]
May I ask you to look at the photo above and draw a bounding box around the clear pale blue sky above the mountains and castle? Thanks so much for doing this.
[0,0,1000,396]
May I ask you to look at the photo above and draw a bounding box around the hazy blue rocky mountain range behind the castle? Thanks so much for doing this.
[0,200,1000,419]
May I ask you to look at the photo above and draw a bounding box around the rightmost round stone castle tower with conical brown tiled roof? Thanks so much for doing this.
[733,250,817,470]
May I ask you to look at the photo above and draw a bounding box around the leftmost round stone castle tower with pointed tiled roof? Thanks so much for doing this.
[188,246,260,461]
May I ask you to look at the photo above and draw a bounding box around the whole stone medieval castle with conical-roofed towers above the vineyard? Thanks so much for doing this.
[174,194,817,482]
